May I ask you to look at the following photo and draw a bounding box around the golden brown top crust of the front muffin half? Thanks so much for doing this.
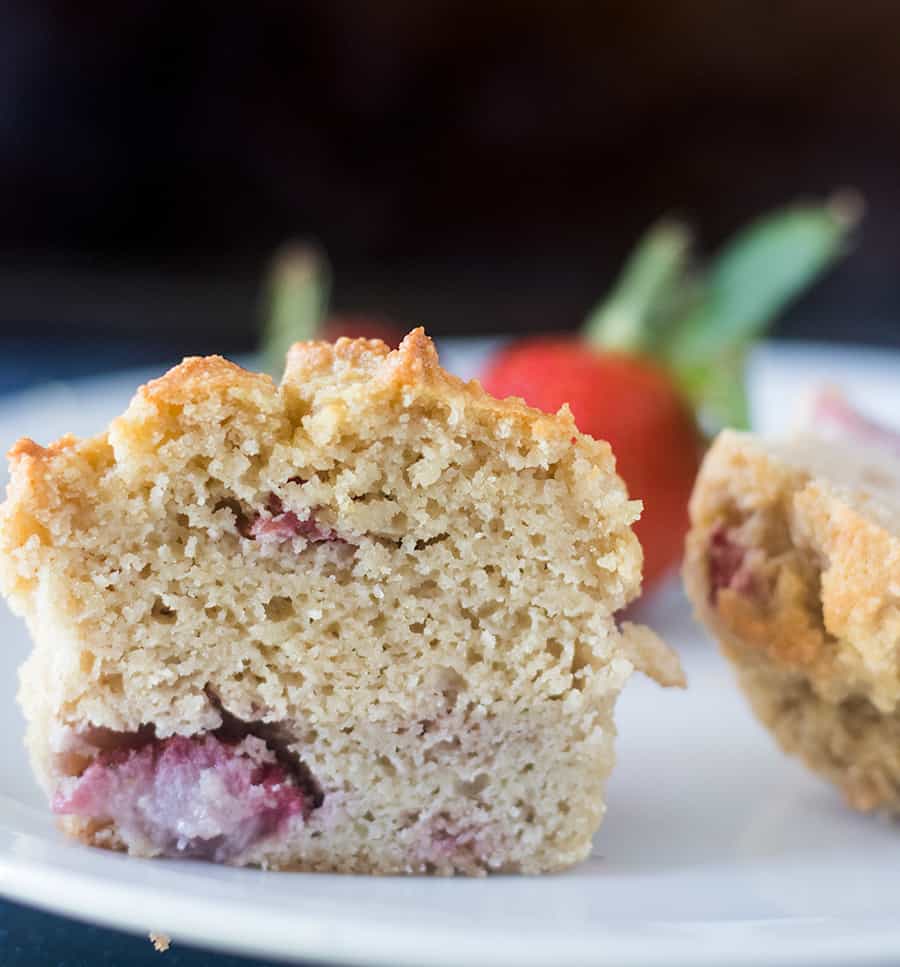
[0,327,628,588]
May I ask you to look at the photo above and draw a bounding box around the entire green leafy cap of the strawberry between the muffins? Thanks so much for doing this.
[583,192,863,433]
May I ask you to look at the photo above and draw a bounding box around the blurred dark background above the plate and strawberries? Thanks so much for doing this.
[0,0,900,365]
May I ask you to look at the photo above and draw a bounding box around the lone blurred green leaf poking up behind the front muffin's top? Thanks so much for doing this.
[261,243,331,377]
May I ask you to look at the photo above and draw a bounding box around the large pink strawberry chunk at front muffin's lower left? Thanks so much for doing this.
[53,734,315,862]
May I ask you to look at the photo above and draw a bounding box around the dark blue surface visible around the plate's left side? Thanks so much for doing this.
[0,339,324,967]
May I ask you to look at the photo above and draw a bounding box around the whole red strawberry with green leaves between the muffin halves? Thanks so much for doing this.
[482,194,860,589]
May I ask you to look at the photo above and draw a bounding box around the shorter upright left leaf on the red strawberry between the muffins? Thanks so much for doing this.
[582,221,691,354]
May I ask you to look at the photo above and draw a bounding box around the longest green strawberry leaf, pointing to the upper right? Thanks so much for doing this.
[664,195,861,372]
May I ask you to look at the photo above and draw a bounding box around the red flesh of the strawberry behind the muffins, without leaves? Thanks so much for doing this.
[482,339,701,588]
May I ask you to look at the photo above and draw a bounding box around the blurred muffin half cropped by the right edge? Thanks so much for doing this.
[684,420,900,813]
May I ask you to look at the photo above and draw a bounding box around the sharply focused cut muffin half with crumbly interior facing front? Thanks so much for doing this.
[0,330,681,874]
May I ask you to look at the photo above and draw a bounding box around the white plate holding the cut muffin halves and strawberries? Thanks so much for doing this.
[0,343,900,967]
